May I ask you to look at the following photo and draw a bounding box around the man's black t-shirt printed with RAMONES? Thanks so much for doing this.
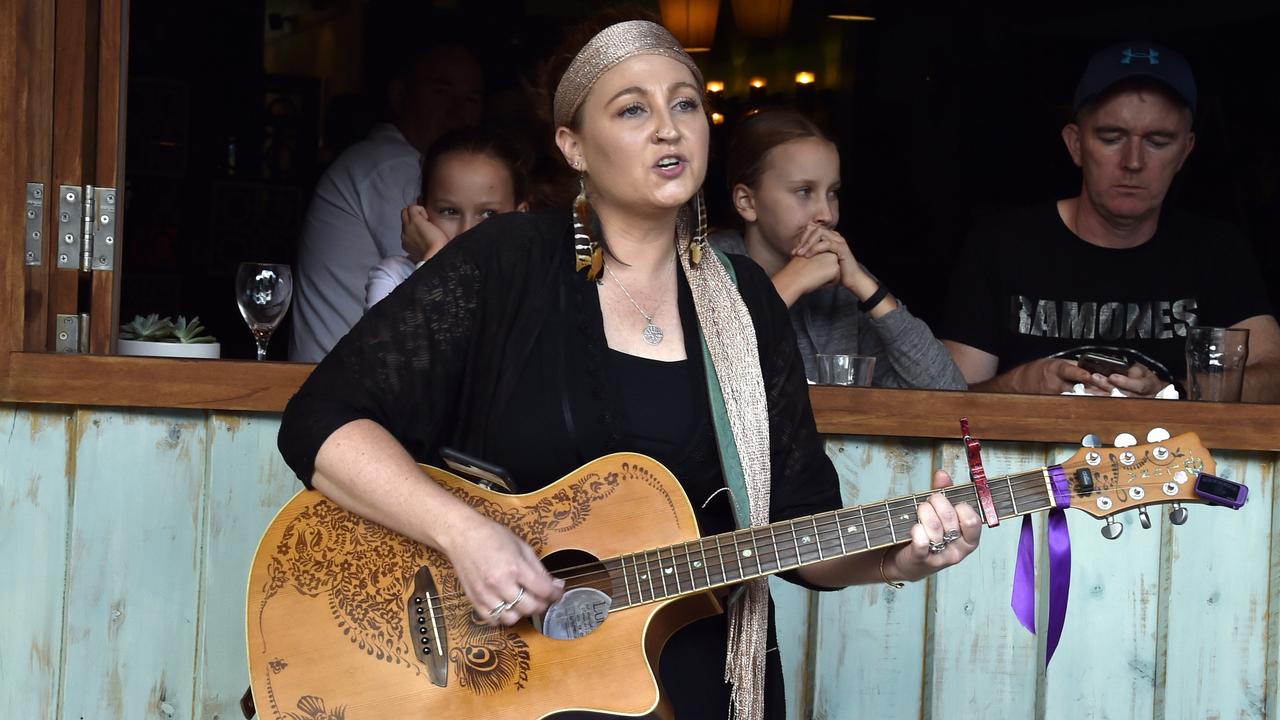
[940,202,1271,380]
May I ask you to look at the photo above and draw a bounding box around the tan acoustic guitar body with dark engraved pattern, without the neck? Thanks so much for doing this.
[247,454,721,720]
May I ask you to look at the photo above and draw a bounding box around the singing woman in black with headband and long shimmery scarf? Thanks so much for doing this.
[279,14,979,719]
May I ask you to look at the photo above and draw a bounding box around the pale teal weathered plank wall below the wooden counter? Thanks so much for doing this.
[0,405,1280,720]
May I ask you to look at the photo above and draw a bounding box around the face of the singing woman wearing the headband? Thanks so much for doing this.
[556,55,709,215]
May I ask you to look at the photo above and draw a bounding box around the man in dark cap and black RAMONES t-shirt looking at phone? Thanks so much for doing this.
[940,44,1280,402]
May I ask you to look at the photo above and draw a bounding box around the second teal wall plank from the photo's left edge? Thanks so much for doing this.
[61,409,206,720]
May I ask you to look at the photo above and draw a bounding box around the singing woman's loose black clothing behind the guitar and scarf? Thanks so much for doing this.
[279,207,840,717]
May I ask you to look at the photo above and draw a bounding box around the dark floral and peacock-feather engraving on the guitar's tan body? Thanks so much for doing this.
[259,464,624,696]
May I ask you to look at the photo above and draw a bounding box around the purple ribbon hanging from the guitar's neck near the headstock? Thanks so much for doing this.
[1010,465,1071,666]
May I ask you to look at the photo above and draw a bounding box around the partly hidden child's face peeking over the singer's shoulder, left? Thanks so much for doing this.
[424,152,522,240]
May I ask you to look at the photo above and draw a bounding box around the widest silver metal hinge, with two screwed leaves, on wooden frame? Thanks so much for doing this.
[58,184,116,273]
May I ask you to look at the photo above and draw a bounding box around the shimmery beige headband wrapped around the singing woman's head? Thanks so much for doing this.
[553,20,704,127]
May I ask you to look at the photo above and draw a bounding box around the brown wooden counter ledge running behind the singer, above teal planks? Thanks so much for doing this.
[0,352,1280,451]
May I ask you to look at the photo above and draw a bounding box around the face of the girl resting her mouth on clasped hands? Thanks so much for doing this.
[735,137,840,255]
